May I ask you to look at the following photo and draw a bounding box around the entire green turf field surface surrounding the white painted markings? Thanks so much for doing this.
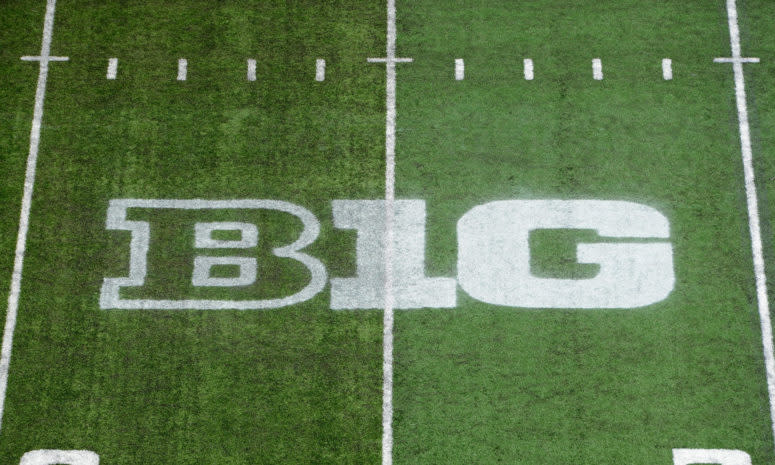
[0,0,775,465]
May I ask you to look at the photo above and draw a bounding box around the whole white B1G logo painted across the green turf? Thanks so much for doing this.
[100,199,675,309]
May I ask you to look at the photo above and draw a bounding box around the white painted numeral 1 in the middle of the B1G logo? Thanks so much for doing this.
[331,200,457,309]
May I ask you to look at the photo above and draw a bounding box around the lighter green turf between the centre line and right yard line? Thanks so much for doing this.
[395,1,773,465]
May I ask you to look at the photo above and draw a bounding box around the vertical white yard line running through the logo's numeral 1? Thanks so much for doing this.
[366,0,412,465]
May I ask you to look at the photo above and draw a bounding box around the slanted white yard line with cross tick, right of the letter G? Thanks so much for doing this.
[714,0,775,454]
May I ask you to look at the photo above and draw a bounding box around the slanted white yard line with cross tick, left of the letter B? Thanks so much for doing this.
[0,0,67,434]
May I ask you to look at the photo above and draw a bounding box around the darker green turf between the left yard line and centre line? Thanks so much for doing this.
[0,0,384,465]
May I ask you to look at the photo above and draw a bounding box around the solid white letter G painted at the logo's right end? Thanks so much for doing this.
[457,200,675,308]
